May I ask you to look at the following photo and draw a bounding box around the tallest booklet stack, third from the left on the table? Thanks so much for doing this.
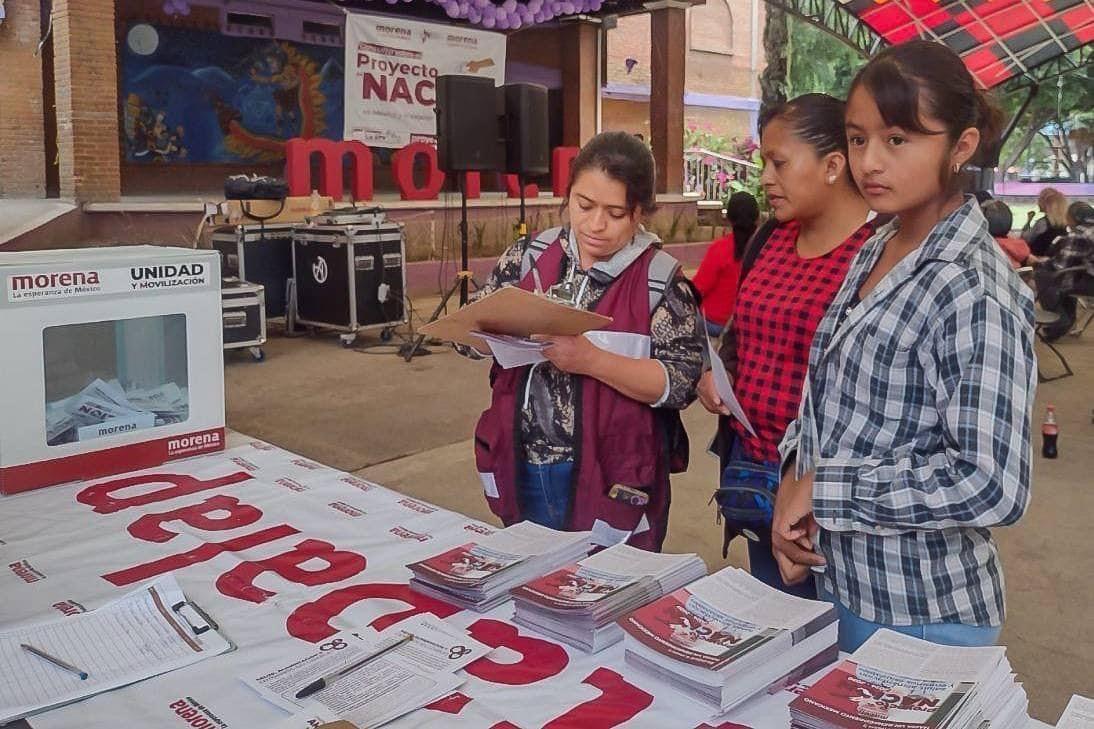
[619,567,839,713]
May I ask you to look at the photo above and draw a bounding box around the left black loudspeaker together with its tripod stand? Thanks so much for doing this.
[400,74,504,362]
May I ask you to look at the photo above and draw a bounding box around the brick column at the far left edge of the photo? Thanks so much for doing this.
[0,0,46,197]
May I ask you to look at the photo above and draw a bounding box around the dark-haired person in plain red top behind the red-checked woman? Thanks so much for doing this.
[691,193,759,337]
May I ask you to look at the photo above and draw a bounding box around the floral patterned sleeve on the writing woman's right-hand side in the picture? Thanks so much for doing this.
[650,275,706,409]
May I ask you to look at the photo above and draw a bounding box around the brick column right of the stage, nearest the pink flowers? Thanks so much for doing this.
[645,0,690,193]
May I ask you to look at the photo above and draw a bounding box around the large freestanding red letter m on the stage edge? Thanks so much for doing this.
[284,137,372,201]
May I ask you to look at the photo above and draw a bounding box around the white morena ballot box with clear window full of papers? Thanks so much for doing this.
[0,245,224,494]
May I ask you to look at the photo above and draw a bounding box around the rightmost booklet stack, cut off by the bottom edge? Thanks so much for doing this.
[790,629,1029,729]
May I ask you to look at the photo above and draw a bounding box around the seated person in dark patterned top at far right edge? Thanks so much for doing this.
[1034,203,1094,342]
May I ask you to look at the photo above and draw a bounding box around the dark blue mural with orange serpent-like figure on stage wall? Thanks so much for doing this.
[121,23,344,164]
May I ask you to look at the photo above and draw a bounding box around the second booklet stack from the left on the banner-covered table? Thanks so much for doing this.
[513,544,707,652]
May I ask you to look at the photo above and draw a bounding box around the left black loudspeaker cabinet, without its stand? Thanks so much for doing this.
[437,76,502,172]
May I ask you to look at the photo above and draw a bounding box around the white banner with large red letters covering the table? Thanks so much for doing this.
[0,442,1050,729]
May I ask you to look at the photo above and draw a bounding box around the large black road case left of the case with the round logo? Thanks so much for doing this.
[212,223,292,319]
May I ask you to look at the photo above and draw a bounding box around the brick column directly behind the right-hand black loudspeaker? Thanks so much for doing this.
[561,19,601,147]
